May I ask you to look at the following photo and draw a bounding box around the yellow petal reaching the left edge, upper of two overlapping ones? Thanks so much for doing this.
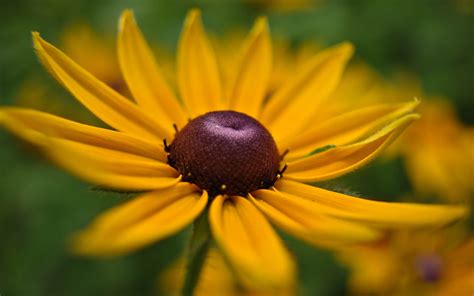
[0,107,166,162]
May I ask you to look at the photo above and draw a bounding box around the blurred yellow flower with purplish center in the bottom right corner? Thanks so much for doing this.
[339,225,474,295]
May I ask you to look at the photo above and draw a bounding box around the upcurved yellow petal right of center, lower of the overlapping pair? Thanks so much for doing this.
[285,114,419,182]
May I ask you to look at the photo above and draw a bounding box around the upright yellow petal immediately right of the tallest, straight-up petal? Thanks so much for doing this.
[229,17,272,118]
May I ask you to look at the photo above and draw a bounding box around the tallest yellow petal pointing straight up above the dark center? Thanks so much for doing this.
[178,9,222,117]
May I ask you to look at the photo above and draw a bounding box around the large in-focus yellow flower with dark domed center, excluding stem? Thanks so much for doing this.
[0,10,466,288]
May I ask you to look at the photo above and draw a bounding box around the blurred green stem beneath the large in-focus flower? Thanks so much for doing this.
[182,210,211,296]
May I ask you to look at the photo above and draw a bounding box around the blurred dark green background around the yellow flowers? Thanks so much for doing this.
[0,0,474,295]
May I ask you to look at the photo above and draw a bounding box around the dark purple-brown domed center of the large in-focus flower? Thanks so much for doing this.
[165,111,280,196]
